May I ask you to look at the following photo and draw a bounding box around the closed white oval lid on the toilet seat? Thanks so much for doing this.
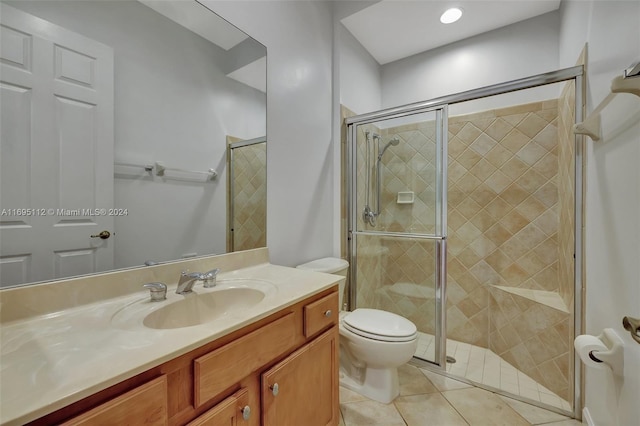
[343,308,417,342]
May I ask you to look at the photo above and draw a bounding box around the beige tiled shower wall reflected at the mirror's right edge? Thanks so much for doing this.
[231,143,267,251]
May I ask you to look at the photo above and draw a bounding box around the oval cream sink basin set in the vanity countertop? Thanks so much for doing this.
[111,278,276,330]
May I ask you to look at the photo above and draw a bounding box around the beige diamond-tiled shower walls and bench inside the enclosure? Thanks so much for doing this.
[348,95,573,398]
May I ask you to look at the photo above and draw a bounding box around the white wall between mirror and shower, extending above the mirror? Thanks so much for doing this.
[203,0,338,266]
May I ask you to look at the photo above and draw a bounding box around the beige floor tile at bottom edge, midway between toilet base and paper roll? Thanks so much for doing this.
[442,388,529,426]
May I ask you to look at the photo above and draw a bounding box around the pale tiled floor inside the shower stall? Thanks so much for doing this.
[415,332,571,411]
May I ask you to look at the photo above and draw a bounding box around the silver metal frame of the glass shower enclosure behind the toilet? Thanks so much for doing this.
[345,65,584,418]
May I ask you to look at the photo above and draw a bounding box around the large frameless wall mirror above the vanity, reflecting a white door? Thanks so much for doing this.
[0,0,267,287]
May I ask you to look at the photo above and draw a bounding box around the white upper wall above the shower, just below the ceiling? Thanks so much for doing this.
[382,12,559,115]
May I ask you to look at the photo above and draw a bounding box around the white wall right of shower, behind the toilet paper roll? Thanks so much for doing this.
[560,0,640,426]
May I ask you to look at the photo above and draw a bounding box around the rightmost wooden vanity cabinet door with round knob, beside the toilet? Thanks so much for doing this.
[262,327,339,426]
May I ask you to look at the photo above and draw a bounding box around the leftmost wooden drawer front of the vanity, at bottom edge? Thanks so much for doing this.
[62,376,169,426]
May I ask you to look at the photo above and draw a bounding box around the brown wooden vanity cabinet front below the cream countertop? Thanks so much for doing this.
[31,286,339,426]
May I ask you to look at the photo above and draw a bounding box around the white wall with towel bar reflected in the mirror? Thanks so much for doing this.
[6,1,266,268]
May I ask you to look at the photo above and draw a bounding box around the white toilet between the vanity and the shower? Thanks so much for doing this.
[298,257,418,404]
